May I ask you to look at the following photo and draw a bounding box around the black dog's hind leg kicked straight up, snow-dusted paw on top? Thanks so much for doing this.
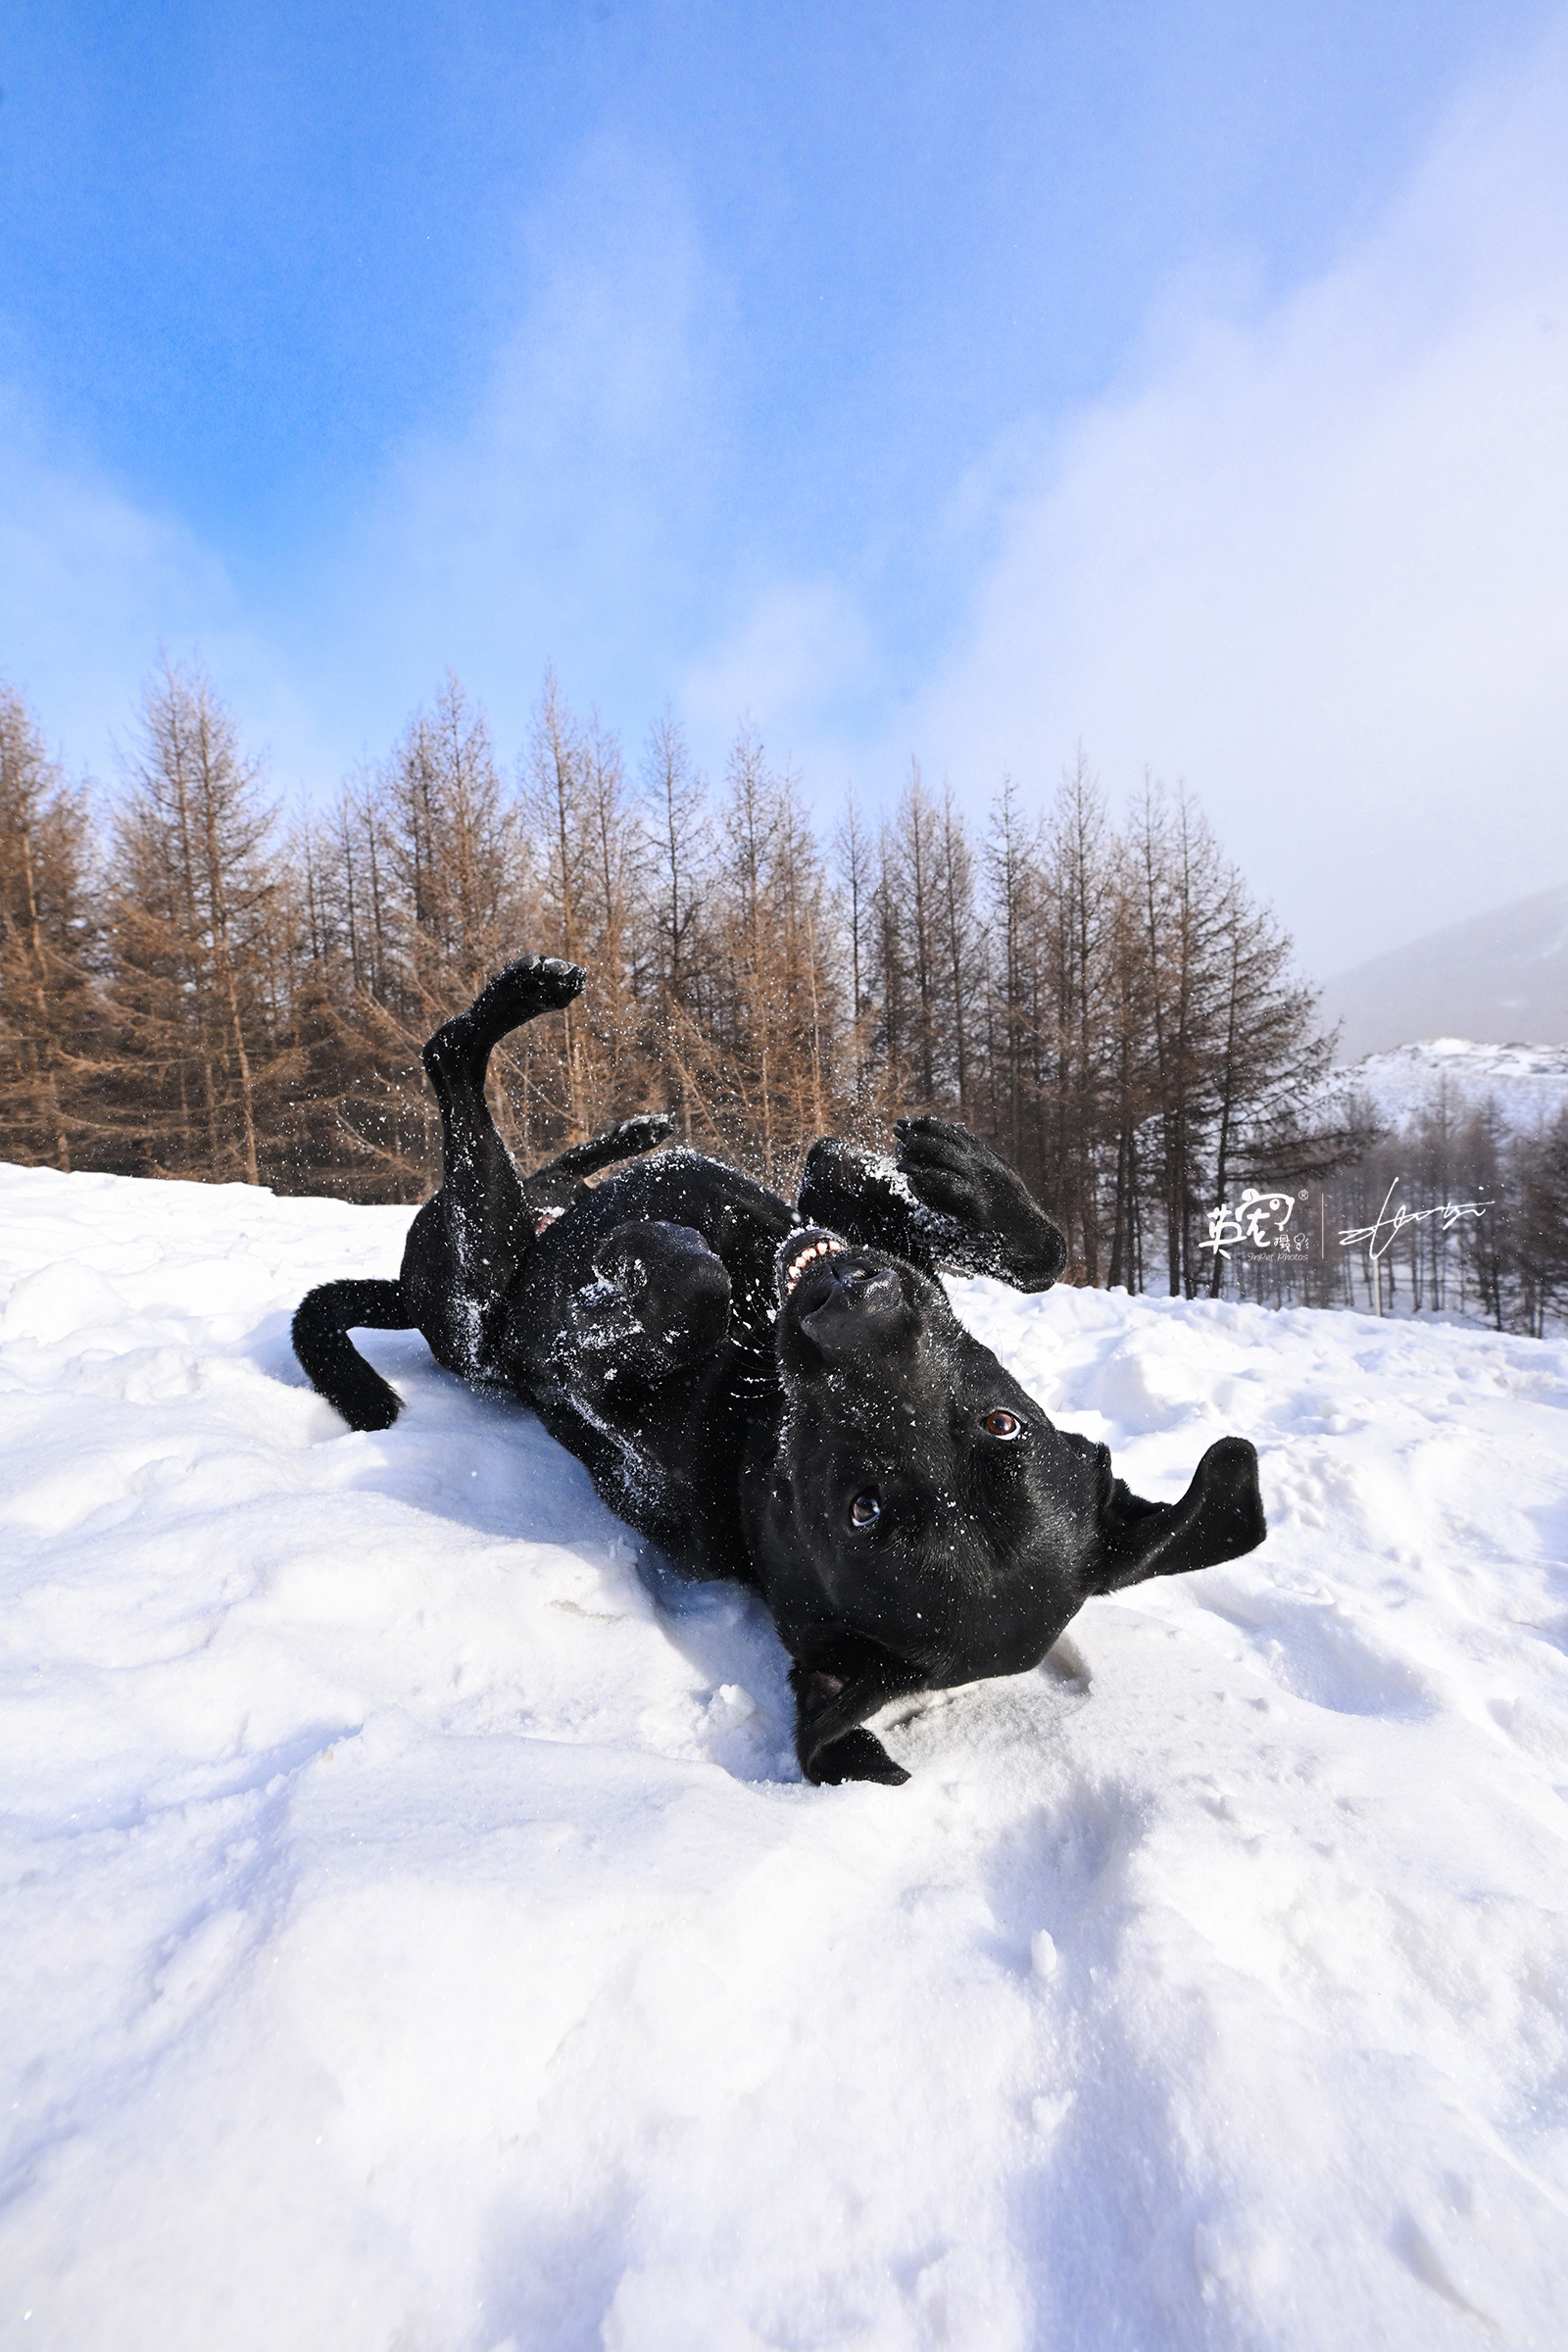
[402,955,583,1381]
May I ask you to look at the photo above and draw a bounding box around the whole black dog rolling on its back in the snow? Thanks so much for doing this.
[294,957,1265,1783]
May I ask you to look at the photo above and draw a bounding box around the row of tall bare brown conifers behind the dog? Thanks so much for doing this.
[0,663,1560,1326]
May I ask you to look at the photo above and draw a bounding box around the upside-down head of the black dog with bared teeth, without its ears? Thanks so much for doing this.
[745,1230,1107,1682]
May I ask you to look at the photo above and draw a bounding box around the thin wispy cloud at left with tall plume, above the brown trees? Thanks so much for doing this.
[0,143,724,790]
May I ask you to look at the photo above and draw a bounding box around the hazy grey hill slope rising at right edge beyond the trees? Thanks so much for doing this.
[1324,887,1568,1060]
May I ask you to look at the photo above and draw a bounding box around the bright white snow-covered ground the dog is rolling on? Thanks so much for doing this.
[0,1169,1568,2352]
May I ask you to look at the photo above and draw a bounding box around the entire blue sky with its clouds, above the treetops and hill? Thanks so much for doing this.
[0,0,1568,971]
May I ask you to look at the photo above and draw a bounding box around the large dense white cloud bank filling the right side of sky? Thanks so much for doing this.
[877,25,1568,971]
